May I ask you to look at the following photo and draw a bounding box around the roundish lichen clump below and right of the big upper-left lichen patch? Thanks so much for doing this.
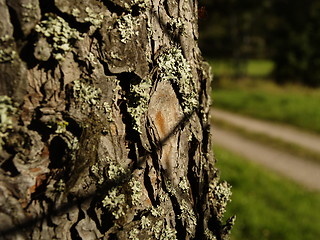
[73,79,101,106]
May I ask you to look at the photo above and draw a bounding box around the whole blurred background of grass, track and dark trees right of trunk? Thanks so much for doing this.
[199,0,320,240]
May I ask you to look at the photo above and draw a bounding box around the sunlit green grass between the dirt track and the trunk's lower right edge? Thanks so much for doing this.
[214,146,320,240]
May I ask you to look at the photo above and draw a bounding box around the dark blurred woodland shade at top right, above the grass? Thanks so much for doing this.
[200,0,320,87]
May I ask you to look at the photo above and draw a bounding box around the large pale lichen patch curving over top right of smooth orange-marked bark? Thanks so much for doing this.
[157,47,198,114]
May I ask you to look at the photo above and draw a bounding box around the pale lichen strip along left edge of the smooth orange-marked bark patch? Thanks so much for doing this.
[128,79,151,133]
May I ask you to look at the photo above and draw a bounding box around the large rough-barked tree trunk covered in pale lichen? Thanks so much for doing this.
[0,0,233,240]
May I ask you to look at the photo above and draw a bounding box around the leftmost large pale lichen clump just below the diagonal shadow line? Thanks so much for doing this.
[102,187,127,219]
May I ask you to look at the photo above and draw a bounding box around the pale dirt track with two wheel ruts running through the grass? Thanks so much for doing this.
[212,110,320,191]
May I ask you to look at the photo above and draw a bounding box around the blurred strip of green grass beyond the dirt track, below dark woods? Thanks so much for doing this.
[213,58,320,133]
